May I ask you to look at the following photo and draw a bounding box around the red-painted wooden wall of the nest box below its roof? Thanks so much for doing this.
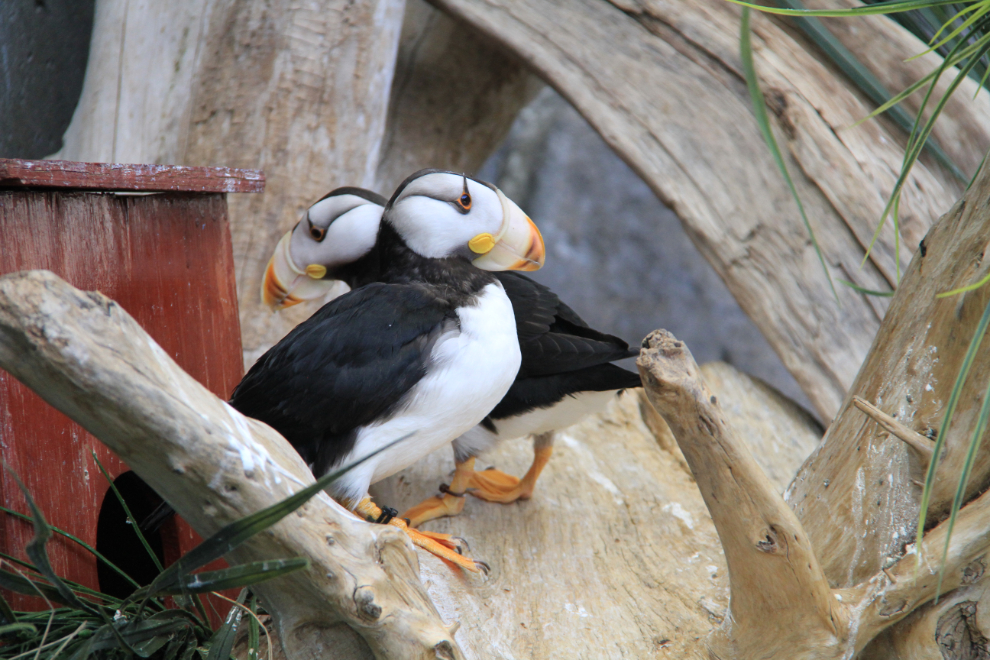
[0,191,243,607]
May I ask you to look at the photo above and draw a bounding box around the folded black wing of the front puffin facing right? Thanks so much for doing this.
[230,283,457,476]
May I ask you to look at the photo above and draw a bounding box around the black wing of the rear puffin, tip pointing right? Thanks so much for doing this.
[493,271,639,379]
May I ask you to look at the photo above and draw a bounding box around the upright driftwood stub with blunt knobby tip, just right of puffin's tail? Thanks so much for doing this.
[637,330,849,658]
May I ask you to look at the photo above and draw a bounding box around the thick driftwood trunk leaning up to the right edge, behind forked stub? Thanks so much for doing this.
[787,160,990,586]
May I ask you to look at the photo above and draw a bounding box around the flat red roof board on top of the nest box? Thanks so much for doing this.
[0,158,265,193]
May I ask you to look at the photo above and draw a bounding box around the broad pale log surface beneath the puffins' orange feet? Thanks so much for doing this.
[373,363,820,660]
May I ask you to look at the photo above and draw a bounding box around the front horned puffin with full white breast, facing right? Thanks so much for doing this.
[230,170,544,570]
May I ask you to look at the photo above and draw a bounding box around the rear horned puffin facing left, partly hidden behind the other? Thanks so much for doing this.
[262,187,641,526]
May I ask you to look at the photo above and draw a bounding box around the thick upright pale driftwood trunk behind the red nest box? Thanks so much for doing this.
[49,0,405,364]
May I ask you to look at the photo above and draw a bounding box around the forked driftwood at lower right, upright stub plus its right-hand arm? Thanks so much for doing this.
[638,330,990,660]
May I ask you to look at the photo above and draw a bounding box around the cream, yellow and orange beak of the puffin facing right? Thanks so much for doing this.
[468,190,546,271]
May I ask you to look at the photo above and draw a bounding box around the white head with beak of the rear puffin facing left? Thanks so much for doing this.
[261,187,387,309]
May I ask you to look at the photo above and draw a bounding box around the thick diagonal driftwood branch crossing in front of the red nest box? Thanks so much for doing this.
[0,271,462,660]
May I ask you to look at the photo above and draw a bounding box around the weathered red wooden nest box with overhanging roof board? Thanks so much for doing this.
[0,159,265,611]
